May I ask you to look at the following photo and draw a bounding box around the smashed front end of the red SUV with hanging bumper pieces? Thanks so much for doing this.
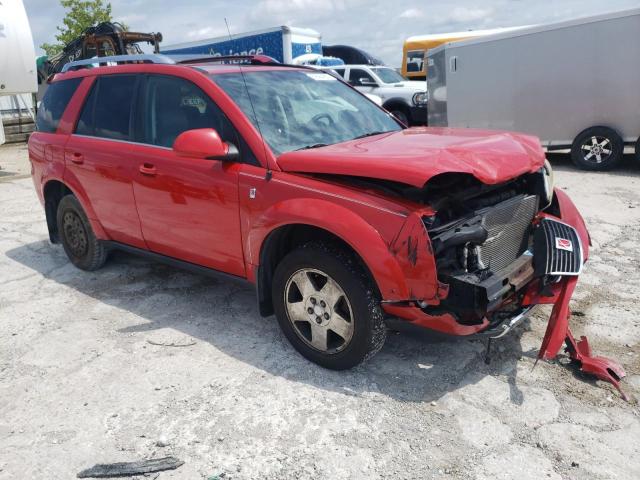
[384,167,626,398]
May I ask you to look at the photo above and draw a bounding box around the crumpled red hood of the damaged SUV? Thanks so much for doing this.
[278,127,545,188]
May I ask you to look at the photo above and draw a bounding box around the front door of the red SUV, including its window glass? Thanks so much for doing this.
[132,75,245,276]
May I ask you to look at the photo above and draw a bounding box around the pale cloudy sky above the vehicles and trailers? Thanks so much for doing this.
[24,0,640,67]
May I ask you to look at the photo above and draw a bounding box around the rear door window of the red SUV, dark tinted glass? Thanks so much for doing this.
[76,75,136,140]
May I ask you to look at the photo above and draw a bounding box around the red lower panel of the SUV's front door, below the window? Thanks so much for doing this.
[127,142,245,276]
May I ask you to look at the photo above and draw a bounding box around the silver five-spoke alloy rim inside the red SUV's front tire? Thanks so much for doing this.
[284,268,353,353]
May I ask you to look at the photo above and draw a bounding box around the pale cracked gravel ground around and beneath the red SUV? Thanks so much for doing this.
[0,150,640,480]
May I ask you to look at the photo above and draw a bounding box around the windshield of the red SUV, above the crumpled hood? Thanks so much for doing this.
[212,70,402,155]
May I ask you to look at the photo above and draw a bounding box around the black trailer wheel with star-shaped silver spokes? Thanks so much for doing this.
[571,127,624,171]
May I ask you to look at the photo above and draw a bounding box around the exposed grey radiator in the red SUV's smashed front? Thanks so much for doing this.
[478,195,538,272]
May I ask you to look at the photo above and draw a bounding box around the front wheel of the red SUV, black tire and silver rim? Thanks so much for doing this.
[272,242,387,370]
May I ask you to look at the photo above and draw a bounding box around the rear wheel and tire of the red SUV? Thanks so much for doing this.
[56,195,107,271]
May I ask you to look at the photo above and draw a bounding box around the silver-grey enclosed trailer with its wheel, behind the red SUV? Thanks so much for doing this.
[427,8,640,170]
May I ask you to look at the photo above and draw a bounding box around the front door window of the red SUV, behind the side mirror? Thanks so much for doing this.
[141,75,258,165]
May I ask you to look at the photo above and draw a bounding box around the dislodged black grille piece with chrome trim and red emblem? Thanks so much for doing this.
[534,218,583,275]
